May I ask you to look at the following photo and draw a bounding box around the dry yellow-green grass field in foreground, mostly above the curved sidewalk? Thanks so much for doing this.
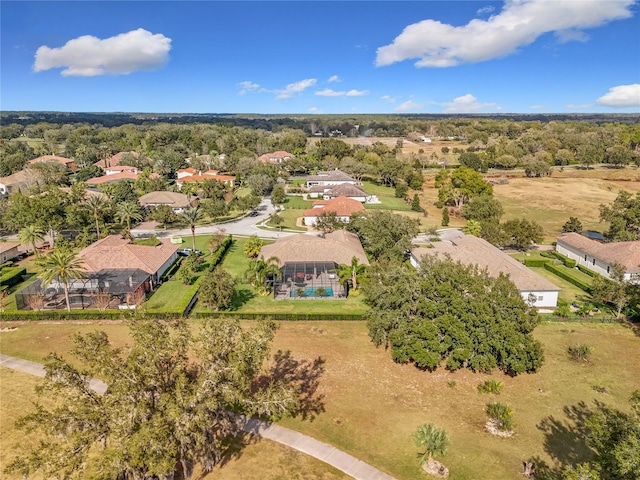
[0,321,640,480]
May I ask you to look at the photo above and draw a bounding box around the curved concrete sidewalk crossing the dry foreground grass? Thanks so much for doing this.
[0,354,395,480]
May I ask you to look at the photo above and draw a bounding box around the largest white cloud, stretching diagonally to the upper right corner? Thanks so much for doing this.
[376,0,635,67]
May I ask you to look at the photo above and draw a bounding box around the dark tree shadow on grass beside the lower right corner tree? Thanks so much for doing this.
[527,402,594,480]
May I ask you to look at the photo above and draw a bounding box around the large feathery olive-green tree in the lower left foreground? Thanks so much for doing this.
[6,318,300,480]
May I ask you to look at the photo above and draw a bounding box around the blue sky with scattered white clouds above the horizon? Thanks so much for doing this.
[0,0,640,114]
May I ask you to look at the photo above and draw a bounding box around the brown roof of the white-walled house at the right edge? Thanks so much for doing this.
[556,232,640,272]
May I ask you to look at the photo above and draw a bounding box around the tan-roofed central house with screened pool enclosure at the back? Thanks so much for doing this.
[260,230,369,299]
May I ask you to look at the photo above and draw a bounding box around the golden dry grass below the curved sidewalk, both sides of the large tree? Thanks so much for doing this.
[0,368,350,480]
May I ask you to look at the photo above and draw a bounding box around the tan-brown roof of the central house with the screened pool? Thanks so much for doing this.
[260,230,369,266]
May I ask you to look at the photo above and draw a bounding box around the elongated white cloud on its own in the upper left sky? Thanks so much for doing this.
[33,28,171,77]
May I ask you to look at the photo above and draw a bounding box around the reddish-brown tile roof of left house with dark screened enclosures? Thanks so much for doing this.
[78,235,180,274]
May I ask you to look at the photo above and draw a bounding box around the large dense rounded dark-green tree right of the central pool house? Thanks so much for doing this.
[363,256,543,375]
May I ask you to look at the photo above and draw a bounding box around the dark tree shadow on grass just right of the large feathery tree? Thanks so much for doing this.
[256,350,325,421]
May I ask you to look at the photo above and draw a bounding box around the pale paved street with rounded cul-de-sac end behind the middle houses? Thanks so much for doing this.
[131,197,301,239]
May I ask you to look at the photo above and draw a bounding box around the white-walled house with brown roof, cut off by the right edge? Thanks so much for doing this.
[556,232,640,283]
